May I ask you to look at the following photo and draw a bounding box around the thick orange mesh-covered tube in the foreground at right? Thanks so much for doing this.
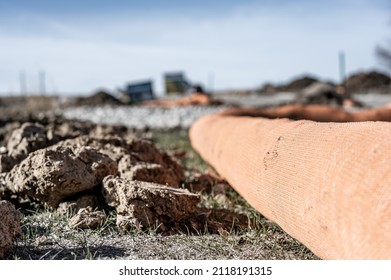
[190,115,391,259]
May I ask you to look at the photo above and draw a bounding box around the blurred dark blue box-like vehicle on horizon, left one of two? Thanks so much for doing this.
[121,81,155,103]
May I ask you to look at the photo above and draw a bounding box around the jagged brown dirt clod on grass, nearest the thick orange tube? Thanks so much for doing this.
[103,176,200,231]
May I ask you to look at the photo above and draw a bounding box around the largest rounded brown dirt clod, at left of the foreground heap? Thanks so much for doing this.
[6,145,118,207]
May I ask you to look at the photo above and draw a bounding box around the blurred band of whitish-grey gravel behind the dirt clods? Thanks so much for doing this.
[62,106,227,129]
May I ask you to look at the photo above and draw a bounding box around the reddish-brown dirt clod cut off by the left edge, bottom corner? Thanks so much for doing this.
[0,200,22,259]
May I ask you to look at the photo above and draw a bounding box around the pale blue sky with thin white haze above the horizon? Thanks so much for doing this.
[0,0,391,94]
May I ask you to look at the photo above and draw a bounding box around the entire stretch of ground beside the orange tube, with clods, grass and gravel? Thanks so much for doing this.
[0,70,390,260]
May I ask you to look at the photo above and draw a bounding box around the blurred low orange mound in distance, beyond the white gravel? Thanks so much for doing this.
[141,93,223,108]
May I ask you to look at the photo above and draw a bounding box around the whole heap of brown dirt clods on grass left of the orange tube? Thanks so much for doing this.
[0,99,251,260]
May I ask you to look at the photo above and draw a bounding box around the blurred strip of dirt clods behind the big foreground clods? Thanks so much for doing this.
[0,114,143,173]
